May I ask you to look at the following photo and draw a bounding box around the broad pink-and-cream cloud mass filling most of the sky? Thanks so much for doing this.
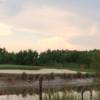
[0,0,100,51]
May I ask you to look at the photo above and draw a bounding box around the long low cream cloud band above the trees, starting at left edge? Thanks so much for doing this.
[1,37,80,52]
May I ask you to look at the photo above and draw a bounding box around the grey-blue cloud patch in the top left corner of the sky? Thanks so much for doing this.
[0,0,26,16]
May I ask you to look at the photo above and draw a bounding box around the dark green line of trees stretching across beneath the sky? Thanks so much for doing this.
[0,48,100,67]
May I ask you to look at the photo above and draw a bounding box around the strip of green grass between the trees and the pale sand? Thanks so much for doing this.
[0,64,94,72]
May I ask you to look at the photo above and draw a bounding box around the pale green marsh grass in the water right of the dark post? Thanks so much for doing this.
[43,89,100,100]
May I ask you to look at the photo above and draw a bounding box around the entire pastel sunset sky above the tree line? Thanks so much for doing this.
[0,0,100,52]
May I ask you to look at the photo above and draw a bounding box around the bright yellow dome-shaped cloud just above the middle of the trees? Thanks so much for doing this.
[34,37,81,51]
